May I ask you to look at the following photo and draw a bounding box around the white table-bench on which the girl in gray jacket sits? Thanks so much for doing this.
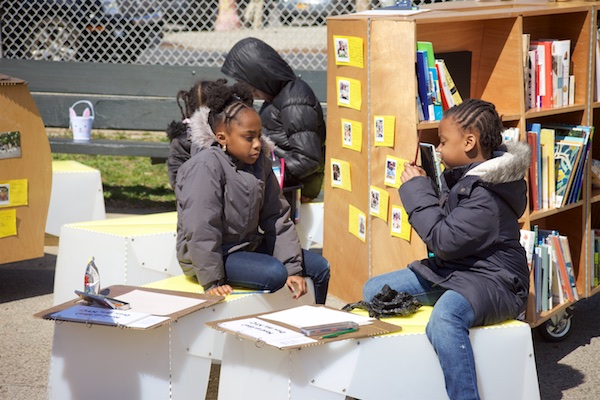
[48,275,315,400]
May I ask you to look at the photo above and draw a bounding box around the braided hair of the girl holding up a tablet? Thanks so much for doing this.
[444,99,504,156]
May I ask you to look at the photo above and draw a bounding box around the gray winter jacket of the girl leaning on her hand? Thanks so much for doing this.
[175,107,302,288]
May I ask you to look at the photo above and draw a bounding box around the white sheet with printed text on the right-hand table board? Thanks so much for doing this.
[219,318,316,347]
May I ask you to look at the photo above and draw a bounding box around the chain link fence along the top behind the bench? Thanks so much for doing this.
[0,0,444,70]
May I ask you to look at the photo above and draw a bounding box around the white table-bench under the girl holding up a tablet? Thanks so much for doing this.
[219,307,540,400]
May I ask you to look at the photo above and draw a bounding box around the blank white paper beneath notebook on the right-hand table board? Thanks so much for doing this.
[260,305,373,328]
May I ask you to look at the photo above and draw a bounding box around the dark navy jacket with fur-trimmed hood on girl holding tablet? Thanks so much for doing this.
[400,143,531,325]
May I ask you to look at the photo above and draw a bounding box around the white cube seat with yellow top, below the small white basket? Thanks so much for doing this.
[45,161,106,236]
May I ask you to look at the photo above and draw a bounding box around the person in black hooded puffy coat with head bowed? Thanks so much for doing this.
[221,38,325,202]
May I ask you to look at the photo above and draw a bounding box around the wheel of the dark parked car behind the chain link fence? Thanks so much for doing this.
[26,17,79,61]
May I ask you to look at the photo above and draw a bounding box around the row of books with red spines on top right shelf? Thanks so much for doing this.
[523,34,575,109]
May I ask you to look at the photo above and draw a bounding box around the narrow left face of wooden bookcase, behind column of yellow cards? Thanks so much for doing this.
[323,20,371,302]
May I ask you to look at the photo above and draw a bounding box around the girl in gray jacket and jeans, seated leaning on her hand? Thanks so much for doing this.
[175,80,329,304]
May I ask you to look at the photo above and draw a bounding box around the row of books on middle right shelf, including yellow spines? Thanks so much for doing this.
[527,123,594,211]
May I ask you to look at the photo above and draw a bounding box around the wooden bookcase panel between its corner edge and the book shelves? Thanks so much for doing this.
[367,20,427,276]
